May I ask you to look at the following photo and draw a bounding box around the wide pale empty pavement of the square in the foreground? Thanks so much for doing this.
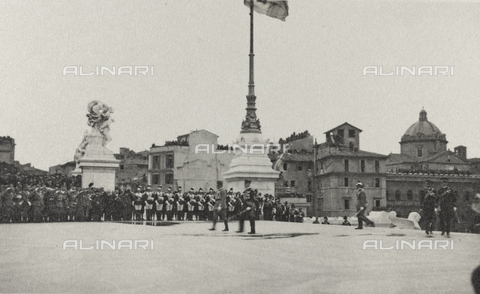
[0,221,480,293]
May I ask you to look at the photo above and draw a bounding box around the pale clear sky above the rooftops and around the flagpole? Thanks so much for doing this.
[0,0,480,170]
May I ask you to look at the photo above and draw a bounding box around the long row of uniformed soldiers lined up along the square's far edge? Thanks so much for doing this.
[0,185,305,223]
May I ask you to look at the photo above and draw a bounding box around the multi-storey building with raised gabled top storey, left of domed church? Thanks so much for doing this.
[312,123,387,217]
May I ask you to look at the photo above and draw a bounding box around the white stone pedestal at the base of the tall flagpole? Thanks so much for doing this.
[223,133,280,195]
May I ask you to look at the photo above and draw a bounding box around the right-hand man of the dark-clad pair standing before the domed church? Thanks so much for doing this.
[437,178,457,238]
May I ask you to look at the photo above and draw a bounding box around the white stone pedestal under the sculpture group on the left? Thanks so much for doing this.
[76,130,120,191]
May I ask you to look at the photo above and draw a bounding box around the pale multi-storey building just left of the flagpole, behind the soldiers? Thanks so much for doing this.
[147,130,235,191]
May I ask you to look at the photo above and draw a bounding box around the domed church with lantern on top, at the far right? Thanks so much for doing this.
[385,109,480,232]
